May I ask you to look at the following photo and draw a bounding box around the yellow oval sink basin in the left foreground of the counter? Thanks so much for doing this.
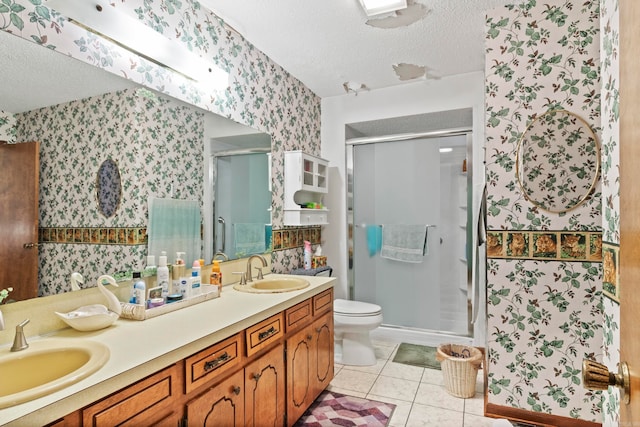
[0,339,109,408]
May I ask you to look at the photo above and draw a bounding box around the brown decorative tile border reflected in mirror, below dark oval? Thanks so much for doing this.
[38,227,147,245]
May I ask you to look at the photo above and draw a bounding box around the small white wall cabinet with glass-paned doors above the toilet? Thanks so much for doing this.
[284,151,329,225]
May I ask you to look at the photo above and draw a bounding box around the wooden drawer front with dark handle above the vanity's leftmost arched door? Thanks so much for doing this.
[185,333,243,393]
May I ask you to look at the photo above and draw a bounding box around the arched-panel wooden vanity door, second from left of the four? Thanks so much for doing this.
[244,343,285,427]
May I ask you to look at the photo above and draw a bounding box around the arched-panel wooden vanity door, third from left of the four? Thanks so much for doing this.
[287,325,316,426]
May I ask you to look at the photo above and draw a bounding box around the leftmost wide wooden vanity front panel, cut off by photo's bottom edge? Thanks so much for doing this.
[82,365,181,427]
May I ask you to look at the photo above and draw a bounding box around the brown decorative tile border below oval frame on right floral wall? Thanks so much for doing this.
[487,230,604,262]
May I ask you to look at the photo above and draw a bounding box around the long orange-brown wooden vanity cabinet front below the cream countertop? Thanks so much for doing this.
[64,289,333,427]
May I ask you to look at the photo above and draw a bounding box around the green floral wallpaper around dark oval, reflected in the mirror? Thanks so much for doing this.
[16,89,204,295]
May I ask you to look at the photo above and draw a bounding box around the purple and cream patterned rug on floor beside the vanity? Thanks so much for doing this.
[294,390,396,427]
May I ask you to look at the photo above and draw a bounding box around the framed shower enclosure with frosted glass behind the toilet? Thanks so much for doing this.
[347,129,472,336]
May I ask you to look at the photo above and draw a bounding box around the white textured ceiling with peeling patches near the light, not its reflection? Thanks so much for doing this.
[200,0,515,97]
